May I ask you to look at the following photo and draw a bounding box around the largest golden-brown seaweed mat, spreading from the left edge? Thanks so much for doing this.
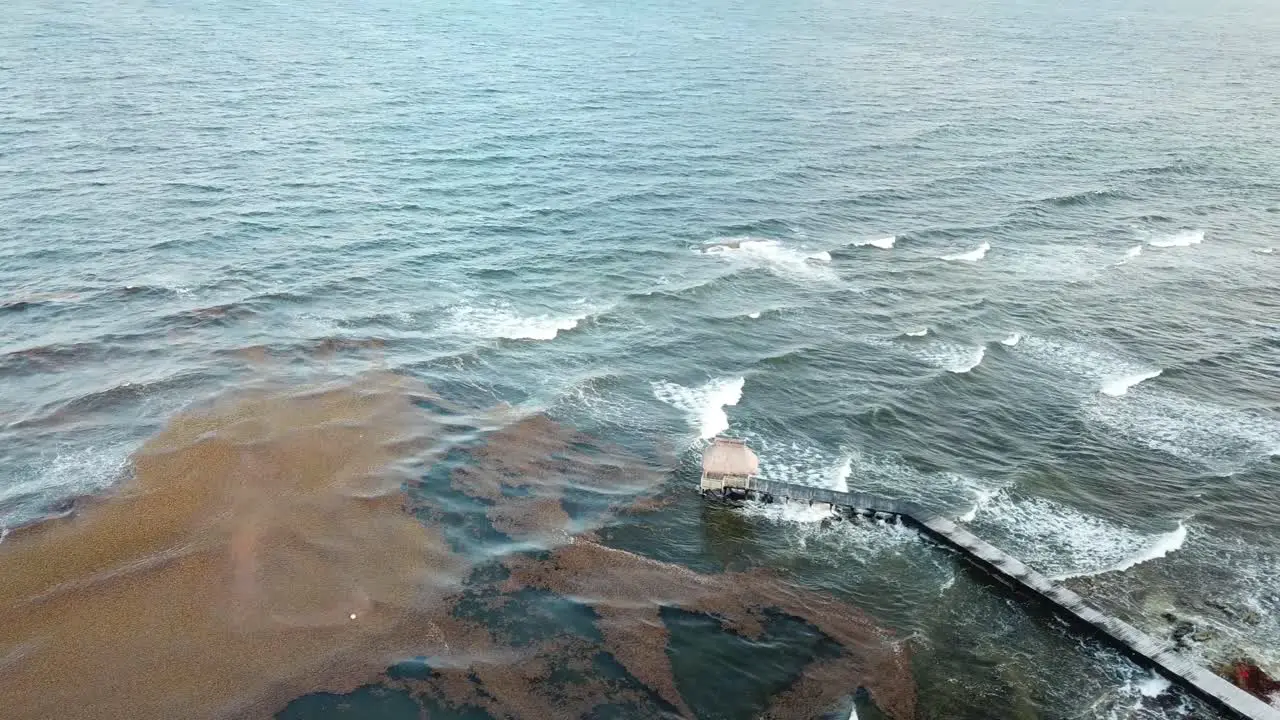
[0,377,463,720]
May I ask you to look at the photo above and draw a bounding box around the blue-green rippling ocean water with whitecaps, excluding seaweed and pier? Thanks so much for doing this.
[0,0,1280,717]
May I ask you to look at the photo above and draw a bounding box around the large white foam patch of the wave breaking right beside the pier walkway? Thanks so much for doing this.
[968,491,1187,578]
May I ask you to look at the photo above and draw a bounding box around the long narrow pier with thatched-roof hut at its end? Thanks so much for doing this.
[701,439,1280,720]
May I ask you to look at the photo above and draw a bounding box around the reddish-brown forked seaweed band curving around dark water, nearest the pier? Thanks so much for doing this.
[504,538,916,720]
